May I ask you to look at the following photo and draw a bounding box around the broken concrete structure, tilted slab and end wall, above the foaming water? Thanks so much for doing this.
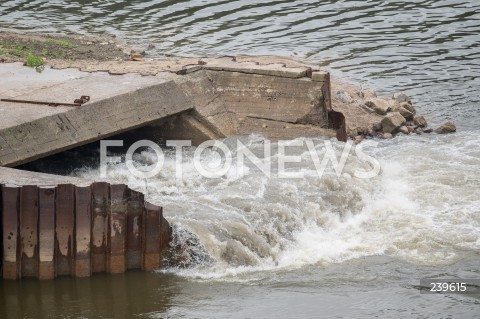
[0,57,340,167]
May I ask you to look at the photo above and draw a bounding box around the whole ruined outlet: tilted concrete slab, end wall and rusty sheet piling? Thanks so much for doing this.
[0,57,338,279]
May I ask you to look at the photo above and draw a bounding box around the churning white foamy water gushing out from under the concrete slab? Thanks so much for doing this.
[72,132,480,280]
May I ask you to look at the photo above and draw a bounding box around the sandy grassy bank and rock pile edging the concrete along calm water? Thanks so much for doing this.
[0,30,456,143]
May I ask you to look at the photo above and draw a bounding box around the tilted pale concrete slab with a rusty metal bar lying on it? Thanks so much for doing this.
[0,66,193,166]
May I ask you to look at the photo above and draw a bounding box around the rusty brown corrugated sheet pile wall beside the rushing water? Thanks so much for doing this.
[0,183,171,280]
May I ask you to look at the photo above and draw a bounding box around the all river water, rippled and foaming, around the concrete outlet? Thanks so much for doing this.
[0,0,480,318]
